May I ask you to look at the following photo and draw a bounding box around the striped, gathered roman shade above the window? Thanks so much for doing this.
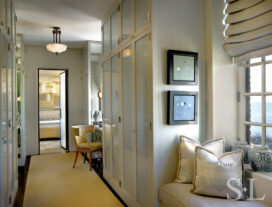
[223,0,272,59]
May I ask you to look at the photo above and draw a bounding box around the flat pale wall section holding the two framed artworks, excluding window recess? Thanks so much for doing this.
[152,0,206,206]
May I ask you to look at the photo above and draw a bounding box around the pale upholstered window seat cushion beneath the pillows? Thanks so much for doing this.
[159,183,267,207]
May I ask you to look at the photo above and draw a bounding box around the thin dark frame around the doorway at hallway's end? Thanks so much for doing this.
[38,68,69,155]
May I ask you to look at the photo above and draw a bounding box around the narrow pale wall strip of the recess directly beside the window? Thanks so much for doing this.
[211,0,238,148]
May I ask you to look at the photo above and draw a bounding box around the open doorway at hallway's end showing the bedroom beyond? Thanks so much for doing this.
[38,69,69,154]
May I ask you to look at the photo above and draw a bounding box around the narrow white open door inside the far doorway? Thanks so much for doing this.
[60,72,68,150]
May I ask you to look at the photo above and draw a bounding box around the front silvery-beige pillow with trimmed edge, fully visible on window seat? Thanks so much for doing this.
[192,147,244,200]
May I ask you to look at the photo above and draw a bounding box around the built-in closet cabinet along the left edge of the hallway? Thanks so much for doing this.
[0,0,18,207]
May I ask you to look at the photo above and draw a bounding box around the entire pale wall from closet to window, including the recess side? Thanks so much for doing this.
[152,0,237,206]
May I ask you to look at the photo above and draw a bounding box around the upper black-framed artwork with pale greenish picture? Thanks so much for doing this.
[167,50,198,85]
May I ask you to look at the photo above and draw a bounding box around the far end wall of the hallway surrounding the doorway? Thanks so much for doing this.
[25,45,83,155]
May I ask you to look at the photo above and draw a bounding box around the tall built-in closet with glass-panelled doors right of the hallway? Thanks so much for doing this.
[101,0,153,207]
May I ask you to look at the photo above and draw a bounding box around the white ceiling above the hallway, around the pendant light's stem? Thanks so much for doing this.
[15,0,114,48]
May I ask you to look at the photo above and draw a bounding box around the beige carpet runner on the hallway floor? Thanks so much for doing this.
[24,153,123,207]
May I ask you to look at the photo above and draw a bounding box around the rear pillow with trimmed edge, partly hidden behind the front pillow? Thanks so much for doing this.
[175,136,225,184]
